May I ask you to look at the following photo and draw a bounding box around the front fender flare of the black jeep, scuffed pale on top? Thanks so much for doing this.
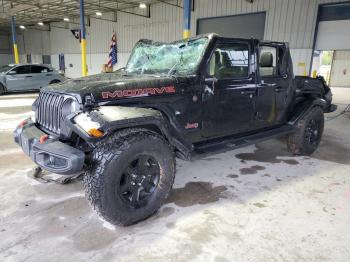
[67,106,193,158]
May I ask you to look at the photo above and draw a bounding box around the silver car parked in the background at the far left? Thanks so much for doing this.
[0,64,65,94]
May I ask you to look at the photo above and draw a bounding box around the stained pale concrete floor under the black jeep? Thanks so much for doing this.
[0,88,350,262]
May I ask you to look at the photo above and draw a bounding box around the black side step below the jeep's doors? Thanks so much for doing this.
[194,125,295,154]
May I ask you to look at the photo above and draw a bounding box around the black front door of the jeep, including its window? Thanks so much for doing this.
[202,41,257,137]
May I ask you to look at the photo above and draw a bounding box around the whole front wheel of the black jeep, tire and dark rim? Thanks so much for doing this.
[84,129,175,225]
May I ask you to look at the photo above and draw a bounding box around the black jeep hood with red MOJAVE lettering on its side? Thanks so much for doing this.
[42,72,178,102]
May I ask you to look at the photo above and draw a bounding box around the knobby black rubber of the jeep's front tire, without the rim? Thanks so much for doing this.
[83,129,175,226]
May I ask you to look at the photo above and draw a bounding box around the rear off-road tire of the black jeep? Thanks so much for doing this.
[287,106,324,155]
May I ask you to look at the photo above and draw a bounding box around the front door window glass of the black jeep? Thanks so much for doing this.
[208,43,249,79]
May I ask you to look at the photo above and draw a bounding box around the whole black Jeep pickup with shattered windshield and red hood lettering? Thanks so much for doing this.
[14,34,336,225]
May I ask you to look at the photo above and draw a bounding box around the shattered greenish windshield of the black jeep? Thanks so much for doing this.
[125,37,209,75]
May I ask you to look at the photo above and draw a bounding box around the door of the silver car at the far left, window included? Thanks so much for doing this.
[6,65,33,91]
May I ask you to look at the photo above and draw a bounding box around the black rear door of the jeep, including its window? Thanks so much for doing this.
[256,43,293,128]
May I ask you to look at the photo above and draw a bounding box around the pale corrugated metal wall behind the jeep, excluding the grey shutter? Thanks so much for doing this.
[6,0,346,74]
